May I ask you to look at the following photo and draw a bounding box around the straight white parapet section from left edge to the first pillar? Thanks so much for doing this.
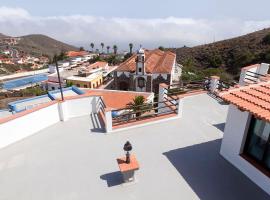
[0,104,59,148]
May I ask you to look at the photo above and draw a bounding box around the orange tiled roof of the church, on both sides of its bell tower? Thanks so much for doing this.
[116,49,176,74]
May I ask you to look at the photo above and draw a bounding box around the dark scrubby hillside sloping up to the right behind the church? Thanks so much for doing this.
[171,28,270,77]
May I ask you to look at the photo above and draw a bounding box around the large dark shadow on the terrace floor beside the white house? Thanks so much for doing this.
[164,140,269,200]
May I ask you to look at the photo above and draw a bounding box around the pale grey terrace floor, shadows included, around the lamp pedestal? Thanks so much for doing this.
[0,94,270,200]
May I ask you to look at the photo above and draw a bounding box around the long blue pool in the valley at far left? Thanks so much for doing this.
[3,74,48,90]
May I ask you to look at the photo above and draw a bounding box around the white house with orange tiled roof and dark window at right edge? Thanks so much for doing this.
[219,63,270,194]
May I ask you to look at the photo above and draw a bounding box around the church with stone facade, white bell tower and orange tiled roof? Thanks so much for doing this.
[114,48,178,93]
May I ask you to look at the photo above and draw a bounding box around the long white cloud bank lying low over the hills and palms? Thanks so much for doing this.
[0,7,270,48]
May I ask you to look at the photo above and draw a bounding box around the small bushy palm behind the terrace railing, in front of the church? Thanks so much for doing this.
[127,96,151,117]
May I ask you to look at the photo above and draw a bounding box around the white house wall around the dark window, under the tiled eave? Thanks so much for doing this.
[220,105,270,195]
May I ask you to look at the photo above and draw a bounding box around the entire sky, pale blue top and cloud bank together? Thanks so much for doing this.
[0,0,270,49]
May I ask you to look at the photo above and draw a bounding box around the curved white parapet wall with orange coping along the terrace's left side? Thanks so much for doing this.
[0,96,100,149]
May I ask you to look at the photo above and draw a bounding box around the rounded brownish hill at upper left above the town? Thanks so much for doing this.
[14,35,78,57]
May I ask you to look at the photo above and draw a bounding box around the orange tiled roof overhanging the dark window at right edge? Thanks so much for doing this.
[219,81,270,122]
